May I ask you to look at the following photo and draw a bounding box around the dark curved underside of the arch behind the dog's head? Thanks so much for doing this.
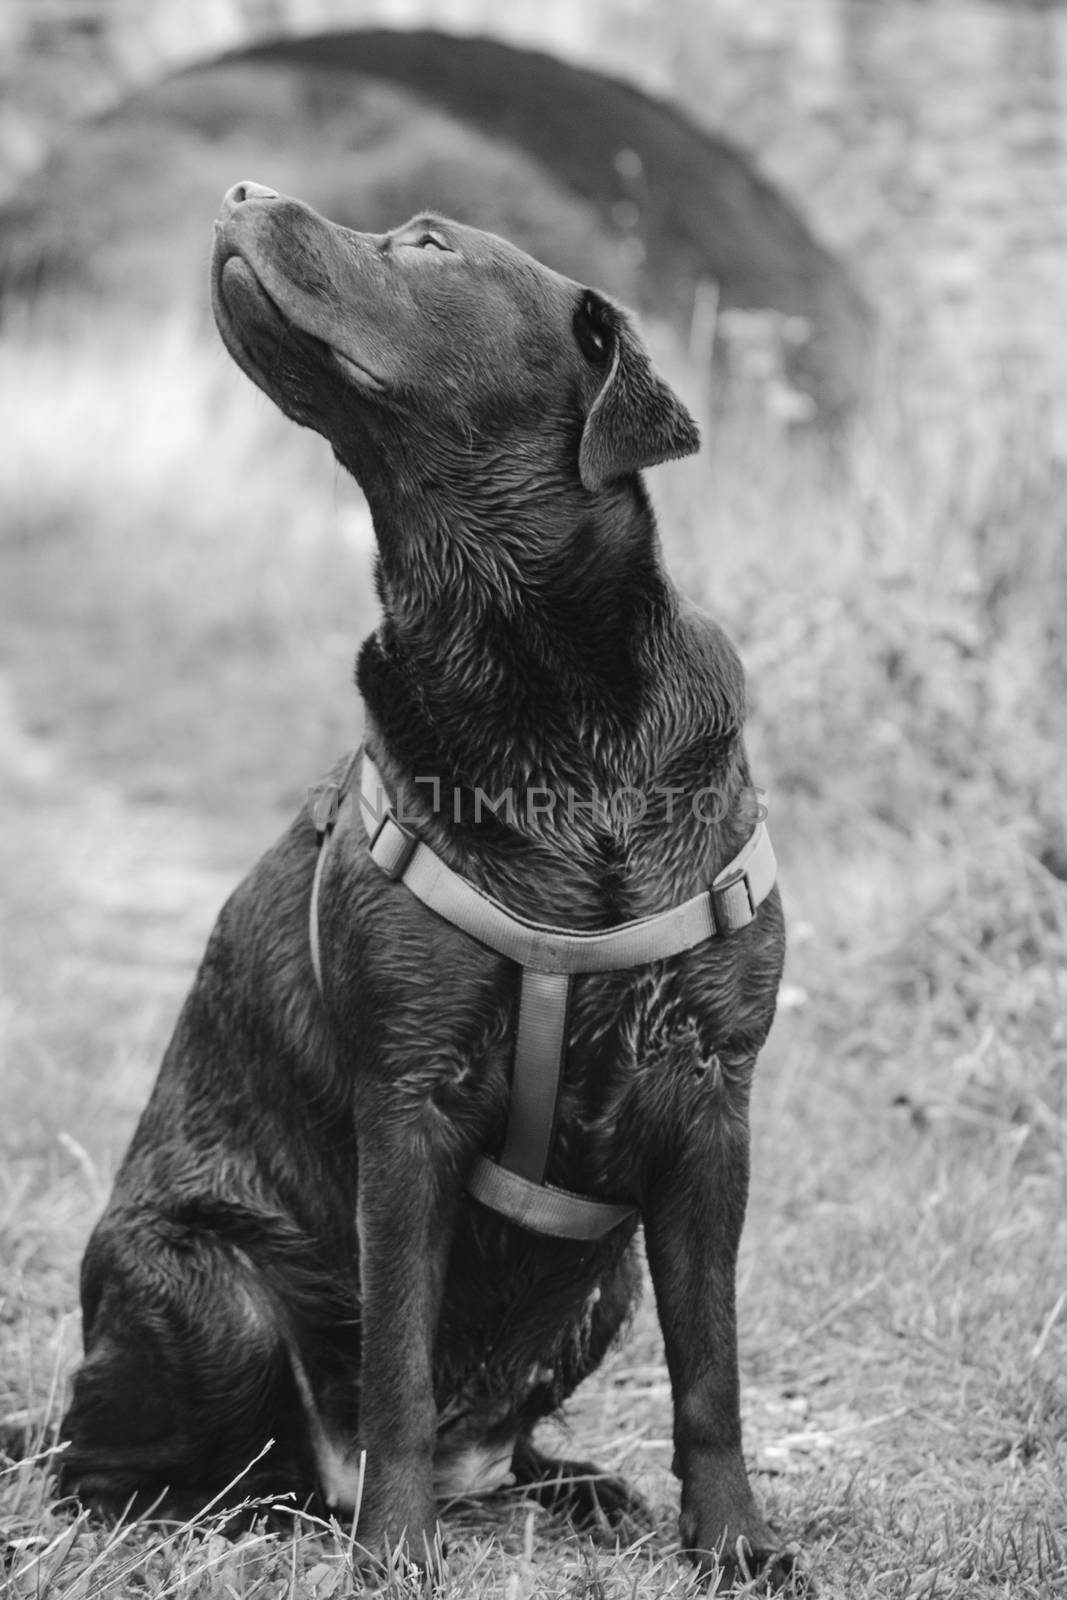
[219,29,873,419]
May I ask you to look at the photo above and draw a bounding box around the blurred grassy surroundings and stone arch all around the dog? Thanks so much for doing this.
[0,0,1067,1595]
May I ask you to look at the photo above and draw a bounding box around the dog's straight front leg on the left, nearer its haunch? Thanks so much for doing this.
[355,1102,461,1565]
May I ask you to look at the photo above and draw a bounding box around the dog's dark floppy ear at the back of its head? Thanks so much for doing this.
[574,290,701,490]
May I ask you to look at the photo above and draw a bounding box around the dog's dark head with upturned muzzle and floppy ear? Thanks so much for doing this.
[211,182,699,510]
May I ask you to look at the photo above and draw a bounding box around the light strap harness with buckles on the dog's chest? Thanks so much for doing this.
[309,750,777,1240]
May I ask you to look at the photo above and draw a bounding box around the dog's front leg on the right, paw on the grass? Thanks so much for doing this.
[645,1112,792,1582]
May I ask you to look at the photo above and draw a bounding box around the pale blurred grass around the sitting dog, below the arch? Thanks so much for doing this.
[0,281,1067,1600]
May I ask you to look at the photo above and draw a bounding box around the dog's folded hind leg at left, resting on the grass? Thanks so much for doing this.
[59,1213,314,1512]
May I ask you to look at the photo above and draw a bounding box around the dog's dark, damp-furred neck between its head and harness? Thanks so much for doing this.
[360,473,646,761]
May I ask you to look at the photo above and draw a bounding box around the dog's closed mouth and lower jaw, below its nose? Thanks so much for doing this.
[213,242,386,403]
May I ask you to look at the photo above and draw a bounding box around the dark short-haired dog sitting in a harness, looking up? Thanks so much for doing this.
[62,182,793,1582]
